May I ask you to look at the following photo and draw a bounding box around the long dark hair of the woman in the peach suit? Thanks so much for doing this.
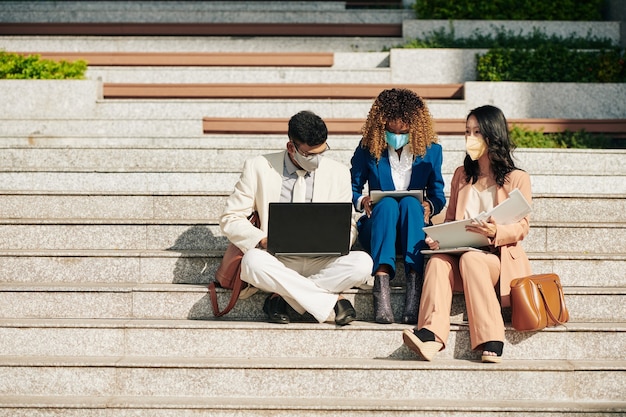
[463,105,519,187]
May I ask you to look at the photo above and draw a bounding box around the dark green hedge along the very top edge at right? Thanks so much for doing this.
[413,0,604,21]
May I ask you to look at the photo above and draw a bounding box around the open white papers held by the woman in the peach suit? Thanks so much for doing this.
[421,188,531,254]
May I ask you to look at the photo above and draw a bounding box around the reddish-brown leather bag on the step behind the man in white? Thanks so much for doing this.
[209,211,260,317]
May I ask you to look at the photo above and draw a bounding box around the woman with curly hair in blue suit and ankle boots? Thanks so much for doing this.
[350,88,446,323]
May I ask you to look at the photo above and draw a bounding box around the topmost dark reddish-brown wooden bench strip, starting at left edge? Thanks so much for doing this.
[0,22,402,38]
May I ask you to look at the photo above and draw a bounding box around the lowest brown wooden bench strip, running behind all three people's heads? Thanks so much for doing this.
[202,117,626,138]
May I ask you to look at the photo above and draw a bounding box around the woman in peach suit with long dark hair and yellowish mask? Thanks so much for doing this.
[403,106,532,363]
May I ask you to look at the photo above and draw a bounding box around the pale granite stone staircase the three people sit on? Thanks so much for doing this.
[0,1,626,417]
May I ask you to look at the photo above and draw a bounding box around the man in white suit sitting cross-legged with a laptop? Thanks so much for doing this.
[220,111,372,326]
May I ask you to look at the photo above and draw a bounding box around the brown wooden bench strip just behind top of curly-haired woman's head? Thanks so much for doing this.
[103,83,463,99]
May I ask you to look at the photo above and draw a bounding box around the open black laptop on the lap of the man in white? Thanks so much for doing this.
[267,203,352,256]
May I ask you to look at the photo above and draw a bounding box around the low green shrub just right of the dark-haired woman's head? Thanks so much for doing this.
[511,125,623,149]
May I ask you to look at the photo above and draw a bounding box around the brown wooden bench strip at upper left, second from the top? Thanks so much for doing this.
[18,52,335,67]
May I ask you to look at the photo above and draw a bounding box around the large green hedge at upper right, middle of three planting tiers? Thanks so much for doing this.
[388,25,626,83]
